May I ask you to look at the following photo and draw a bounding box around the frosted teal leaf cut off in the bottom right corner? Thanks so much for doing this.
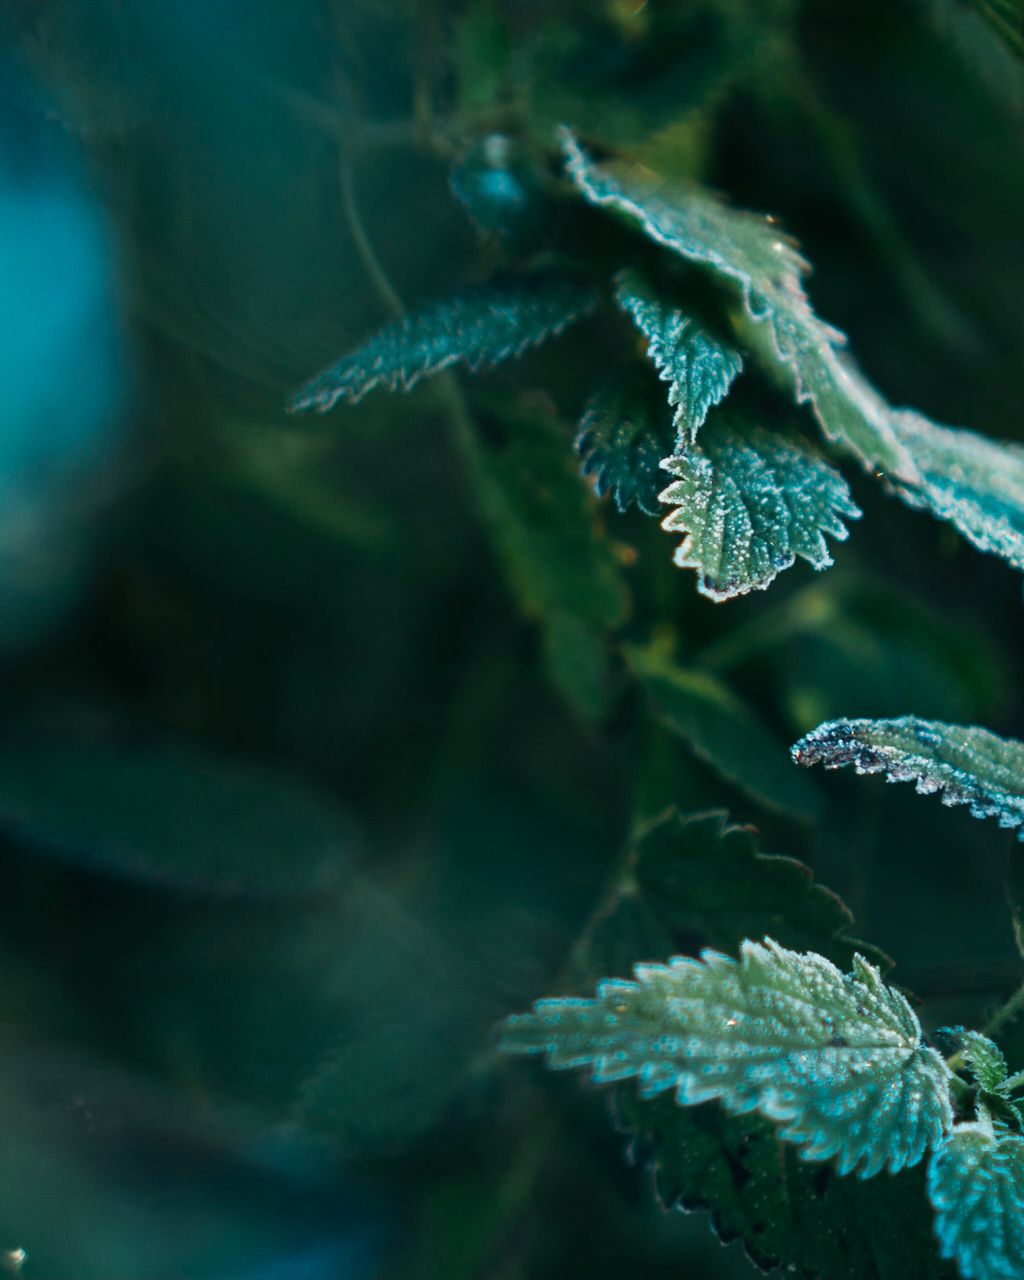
[928,1114,1024,1280]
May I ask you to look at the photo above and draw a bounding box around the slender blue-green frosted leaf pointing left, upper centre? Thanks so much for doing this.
[288,271,598,413]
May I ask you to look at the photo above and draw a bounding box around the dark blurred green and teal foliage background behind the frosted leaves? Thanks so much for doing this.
[0,0,1024,1280]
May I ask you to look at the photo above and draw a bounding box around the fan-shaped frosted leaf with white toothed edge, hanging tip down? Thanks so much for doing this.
[660,410,860,600]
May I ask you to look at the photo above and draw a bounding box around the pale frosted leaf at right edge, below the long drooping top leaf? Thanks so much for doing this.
[893,411,1024,570]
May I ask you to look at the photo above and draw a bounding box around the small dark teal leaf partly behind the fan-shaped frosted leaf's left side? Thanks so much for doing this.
[576,374,672,516]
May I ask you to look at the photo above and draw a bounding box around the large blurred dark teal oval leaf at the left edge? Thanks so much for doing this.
[0,736,352,895]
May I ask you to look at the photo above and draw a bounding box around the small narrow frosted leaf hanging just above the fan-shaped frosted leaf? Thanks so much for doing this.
[616,271,744,449]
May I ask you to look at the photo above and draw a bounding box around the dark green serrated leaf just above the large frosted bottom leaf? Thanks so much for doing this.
[624,810,884,972]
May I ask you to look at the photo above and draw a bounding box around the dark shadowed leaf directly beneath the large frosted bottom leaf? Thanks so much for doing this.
[614,1085,945,1280]
